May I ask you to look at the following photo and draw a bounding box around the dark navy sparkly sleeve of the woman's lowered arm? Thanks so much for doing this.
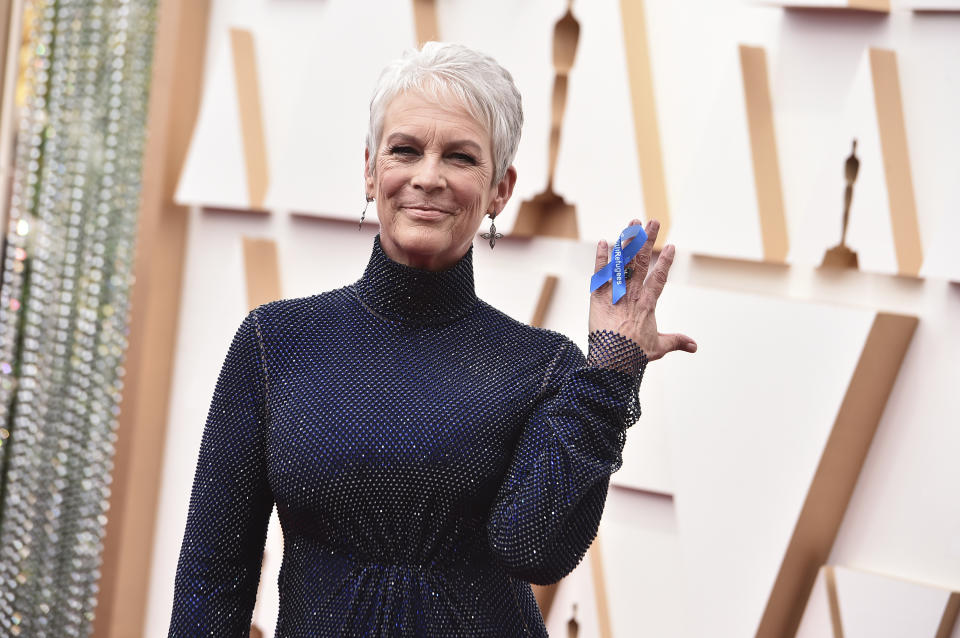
[169,310,273,638]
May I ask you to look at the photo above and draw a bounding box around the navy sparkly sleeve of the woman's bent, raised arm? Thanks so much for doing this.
[487,332,646,584]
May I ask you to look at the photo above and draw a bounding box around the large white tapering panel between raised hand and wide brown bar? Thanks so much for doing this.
[658,285,874,636]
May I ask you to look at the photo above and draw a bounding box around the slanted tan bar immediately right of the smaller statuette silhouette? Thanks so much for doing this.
[870,49,923,277]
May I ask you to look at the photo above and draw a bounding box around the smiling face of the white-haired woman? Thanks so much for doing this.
[365,92,517,270]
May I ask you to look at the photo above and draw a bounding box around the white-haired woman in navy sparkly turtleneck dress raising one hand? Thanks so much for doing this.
[170,43,695,638]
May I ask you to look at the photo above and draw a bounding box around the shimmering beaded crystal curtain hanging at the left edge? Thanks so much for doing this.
[0,0,156,638]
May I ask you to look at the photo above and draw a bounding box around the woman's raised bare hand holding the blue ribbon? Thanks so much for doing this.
[589,219,697,361]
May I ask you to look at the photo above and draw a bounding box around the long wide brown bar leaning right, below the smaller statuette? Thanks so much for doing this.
[756,312,918,638]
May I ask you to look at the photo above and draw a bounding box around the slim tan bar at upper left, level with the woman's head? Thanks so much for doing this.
[230,29,270,208]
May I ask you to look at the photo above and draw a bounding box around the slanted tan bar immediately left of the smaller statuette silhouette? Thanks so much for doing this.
[740,44,790,263]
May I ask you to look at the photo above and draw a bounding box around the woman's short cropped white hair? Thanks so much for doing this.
[367,42,523,184]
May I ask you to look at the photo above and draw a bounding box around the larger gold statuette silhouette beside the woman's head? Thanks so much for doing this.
[511,0,580,239]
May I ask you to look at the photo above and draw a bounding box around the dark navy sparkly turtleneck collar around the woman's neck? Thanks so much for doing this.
[356,233,477,325]
